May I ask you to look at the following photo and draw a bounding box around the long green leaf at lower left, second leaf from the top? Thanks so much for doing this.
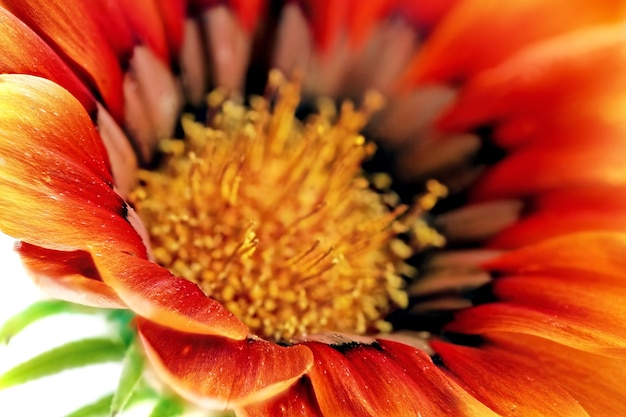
[0,338,125,389]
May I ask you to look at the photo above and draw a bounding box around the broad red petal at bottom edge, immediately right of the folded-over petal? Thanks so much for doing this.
[306,340,495,417]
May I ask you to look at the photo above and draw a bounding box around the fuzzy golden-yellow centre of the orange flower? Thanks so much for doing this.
[131,74,444,341]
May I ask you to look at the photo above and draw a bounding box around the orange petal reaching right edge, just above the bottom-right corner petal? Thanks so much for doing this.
[446,273,626,355]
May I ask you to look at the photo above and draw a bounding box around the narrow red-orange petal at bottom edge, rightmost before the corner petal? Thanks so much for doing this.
[431,340,589,417]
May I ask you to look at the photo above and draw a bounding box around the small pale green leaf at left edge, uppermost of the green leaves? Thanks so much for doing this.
[0,300,100,343]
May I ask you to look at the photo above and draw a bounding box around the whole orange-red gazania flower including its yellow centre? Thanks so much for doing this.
[0,0,626,416]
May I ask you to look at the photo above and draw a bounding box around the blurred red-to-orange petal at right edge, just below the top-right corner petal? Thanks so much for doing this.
[440,24,626,148]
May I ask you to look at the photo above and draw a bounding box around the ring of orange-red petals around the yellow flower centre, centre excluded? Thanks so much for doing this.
[0,0,626,416]
